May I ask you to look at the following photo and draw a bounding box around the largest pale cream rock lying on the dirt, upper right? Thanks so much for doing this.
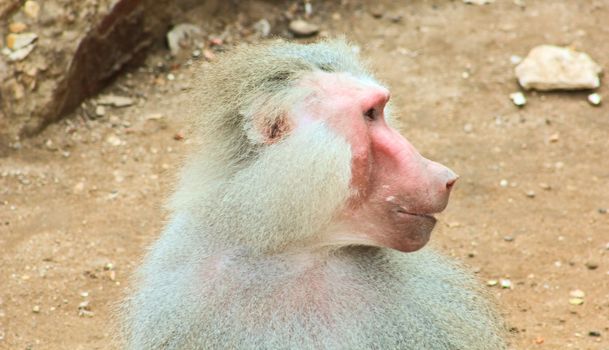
[515,45,602,91]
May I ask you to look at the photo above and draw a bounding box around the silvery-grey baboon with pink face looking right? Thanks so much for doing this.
[124,40,505,350]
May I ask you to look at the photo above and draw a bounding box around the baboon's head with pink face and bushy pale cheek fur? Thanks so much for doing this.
[185,41,457,252]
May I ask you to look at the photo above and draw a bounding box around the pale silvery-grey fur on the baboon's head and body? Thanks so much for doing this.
[124,41,505,350]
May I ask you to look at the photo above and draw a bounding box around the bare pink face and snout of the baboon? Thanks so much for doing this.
[297,72,457,252]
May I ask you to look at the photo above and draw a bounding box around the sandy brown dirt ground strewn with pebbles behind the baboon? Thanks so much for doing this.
[0,0,609,350]
